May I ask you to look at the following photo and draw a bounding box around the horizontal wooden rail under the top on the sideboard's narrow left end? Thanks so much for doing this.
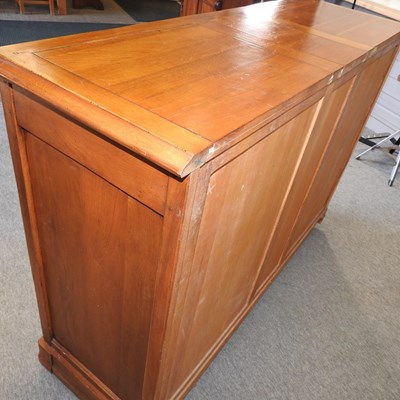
[13,86,168,215]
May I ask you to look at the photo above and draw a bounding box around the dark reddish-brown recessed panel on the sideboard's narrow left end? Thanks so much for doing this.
[26,134,163,398]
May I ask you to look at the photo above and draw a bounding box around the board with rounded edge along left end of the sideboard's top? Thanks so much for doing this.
[0,49,212,177]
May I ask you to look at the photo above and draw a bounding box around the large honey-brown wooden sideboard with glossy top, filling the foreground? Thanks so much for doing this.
[0,0,400,400]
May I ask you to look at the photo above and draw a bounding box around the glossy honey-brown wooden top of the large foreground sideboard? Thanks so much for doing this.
[0,0,400,177]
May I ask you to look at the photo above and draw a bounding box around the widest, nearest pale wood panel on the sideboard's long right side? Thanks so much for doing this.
[164,105,318,395]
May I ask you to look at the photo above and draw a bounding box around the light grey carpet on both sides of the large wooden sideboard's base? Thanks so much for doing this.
[0,97,400,400]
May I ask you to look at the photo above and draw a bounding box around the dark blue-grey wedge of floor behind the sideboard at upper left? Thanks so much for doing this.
[0,21,126,46]
